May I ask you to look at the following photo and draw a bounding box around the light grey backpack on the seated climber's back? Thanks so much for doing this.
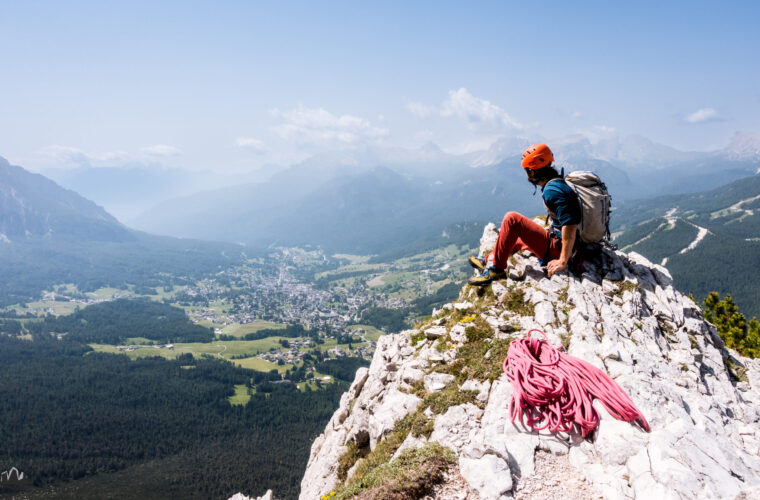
[565,171,612,243]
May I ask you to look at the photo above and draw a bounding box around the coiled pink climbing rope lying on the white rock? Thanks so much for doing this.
[502,329,650,437]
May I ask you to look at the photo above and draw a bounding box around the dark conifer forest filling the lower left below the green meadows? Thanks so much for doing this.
[0,334,344,499]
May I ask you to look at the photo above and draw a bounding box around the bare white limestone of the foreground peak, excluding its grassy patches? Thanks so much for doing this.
[300,224,760,500]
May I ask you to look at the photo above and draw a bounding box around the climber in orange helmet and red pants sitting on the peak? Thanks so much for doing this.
[467,144,581,286]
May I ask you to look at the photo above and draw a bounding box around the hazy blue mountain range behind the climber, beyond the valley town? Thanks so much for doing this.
[127,132,760,253]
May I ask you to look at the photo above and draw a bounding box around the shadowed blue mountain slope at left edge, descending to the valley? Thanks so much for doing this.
[0,158,245,307]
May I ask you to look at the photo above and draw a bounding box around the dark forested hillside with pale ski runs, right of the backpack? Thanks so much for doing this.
[613,175,760,316]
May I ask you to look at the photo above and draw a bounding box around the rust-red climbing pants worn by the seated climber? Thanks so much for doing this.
[493,212,562,269]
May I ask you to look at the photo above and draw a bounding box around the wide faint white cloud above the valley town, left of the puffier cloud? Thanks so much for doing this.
[269,106,388,146]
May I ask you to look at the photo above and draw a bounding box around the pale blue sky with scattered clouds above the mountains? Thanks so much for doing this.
[0,0,760,170]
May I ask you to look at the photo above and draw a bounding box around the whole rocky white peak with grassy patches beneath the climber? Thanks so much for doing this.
[300,225,760,500]
